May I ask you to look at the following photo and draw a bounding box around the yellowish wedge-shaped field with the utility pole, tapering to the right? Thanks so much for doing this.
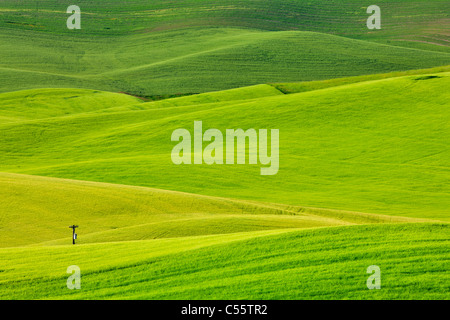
[0,173,426,247]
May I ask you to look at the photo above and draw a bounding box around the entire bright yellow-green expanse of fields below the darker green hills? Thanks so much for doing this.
[0,68,450,299]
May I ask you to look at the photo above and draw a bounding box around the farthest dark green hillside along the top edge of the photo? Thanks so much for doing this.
[0,0,449,47]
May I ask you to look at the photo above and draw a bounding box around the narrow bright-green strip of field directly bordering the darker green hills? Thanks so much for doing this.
[0,65,450,120]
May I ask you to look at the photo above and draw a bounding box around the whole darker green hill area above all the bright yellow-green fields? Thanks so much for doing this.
[0,0,450,97]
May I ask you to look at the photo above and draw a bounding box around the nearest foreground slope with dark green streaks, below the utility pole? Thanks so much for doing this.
[0,223,450,300]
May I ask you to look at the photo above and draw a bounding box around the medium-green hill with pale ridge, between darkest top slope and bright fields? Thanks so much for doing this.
[0,28,450,96]
